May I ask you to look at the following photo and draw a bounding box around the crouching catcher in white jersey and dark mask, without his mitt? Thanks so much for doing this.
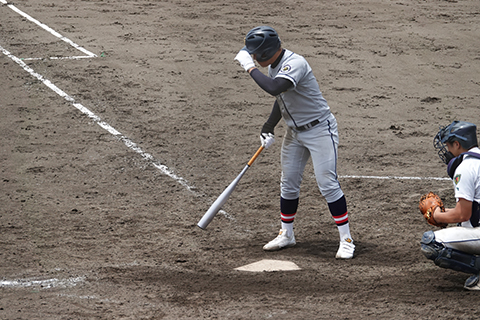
[421,121,480,290]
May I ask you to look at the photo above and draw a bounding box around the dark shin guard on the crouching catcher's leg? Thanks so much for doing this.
[420,231,480,274]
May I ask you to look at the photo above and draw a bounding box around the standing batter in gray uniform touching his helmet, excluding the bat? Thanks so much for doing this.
[235,26,355,259]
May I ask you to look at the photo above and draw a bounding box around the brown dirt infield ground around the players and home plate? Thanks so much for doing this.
[0,0,480,319]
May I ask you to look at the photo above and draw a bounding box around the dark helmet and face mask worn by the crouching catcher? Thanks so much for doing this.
[433,120,478,164]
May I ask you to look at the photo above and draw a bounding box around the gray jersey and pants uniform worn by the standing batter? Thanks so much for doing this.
[268,49,343,203]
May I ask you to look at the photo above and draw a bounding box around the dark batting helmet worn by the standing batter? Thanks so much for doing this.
[244,26,281,62]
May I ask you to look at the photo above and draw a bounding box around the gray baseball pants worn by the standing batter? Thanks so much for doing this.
[281,114,343,203]
